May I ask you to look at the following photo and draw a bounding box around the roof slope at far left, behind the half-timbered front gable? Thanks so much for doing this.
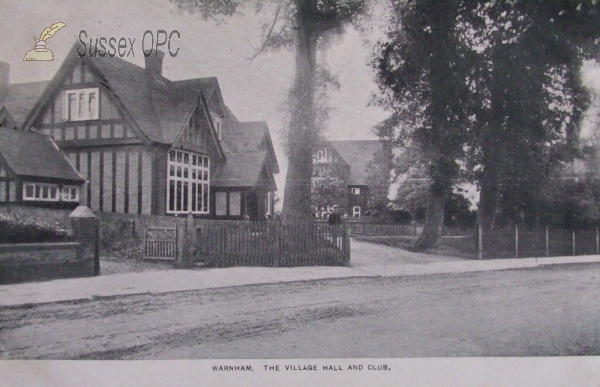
[0,81,50,129]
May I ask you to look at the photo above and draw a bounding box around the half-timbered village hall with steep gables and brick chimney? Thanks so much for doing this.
[0,45,279,220]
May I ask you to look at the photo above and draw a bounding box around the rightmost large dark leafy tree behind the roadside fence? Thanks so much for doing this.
[459,0,600,229]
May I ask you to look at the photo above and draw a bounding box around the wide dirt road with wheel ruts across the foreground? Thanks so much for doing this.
[0,264,600,359]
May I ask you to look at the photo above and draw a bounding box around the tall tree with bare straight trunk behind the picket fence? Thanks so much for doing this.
[175,0,367,223]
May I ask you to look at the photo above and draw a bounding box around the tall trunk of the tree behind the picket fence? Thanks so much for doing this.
[282,12,317,223]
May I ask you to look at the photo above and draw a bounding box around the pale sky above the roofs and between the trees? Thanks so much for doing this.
[0,0,386,209]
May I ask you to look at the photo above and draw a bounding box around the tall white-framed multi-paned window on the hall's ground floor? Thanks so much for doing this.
[167,149,210,214]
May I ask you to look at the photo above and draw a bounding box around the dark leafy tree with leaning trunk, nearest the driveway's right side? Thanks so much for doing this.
[373,0,471,249]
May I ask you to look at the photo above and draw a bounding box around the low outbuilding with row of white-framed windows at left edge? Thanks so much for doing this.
[0,128,84,208]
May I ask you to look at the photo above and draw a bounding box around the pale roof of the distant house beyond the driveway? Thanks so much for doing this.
[329,140,382,185]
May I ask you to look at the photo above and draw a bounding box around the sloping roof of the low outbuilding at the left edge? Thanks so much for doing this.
[0,128,84,184]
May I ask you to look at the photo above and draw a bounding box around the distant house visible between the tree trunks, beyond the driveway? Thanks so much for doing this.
[312,140,382,218]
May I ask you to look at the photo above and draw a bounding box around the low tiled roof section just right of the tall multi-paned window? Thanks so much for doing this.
[213,152,267,187]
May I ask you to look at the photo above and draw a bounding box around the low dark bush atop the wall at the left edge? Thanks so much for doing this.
[0,214,74,243]
